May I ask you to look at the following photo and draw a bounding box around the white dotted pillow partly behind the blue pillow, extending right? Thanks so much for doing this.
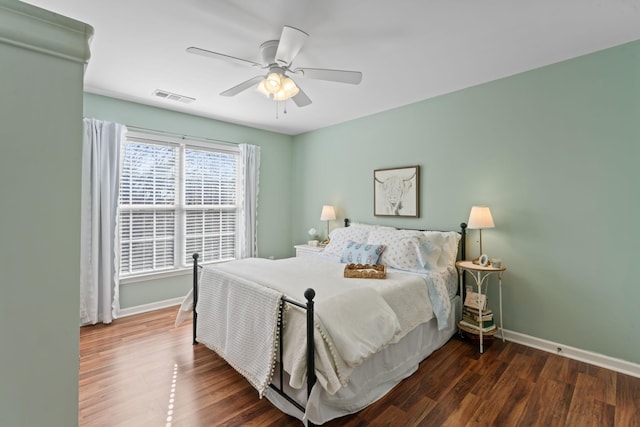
[367,228,441,271]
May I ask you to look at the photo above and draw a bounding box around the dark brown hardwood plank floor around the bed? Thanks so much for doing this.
[79,308,640,427]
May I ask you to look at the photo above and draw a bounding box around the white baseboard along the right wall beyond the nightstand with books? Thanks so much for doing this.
[502,329,640,378]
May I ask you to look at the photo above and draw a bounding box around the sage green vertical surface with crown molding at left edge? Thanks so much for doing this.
[0,0,92,427]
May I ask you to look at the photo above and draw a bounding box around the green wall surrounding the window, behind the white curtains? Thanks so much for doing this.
[84,93,292,308]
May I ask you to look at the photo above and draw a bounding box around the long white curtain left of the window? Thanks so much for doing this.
[80,119,127,325]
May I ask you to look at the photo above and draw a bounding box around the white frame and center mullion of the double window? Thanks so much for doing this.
[117,131,242,284]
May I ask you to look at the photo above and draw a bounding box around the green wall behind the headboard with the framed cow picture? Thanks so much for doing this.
[292,42,640,363]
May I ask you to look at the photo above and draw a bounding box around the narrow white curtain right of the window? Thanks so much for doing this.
[238,144,260,258]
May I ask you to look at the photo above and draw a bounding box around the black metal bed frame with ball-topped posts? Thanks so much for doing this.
[193,218,467,427]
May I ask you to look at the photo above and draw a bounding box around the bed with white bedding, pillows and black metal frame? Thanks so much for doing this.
[179,220,466,425]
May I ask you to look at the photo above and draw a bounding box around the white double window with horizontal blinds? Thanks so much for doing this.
[119,133,239,278]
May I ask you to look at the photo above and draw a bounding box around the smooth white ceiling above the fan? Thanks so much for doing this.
[22,0,640,135]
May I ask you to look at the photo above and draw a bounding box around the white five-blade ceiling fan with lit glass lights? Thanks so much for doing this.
[187,25,362,107]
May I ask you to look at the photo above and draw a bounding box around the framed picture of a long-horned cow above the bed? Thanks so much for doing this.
[373,166,420,218]
